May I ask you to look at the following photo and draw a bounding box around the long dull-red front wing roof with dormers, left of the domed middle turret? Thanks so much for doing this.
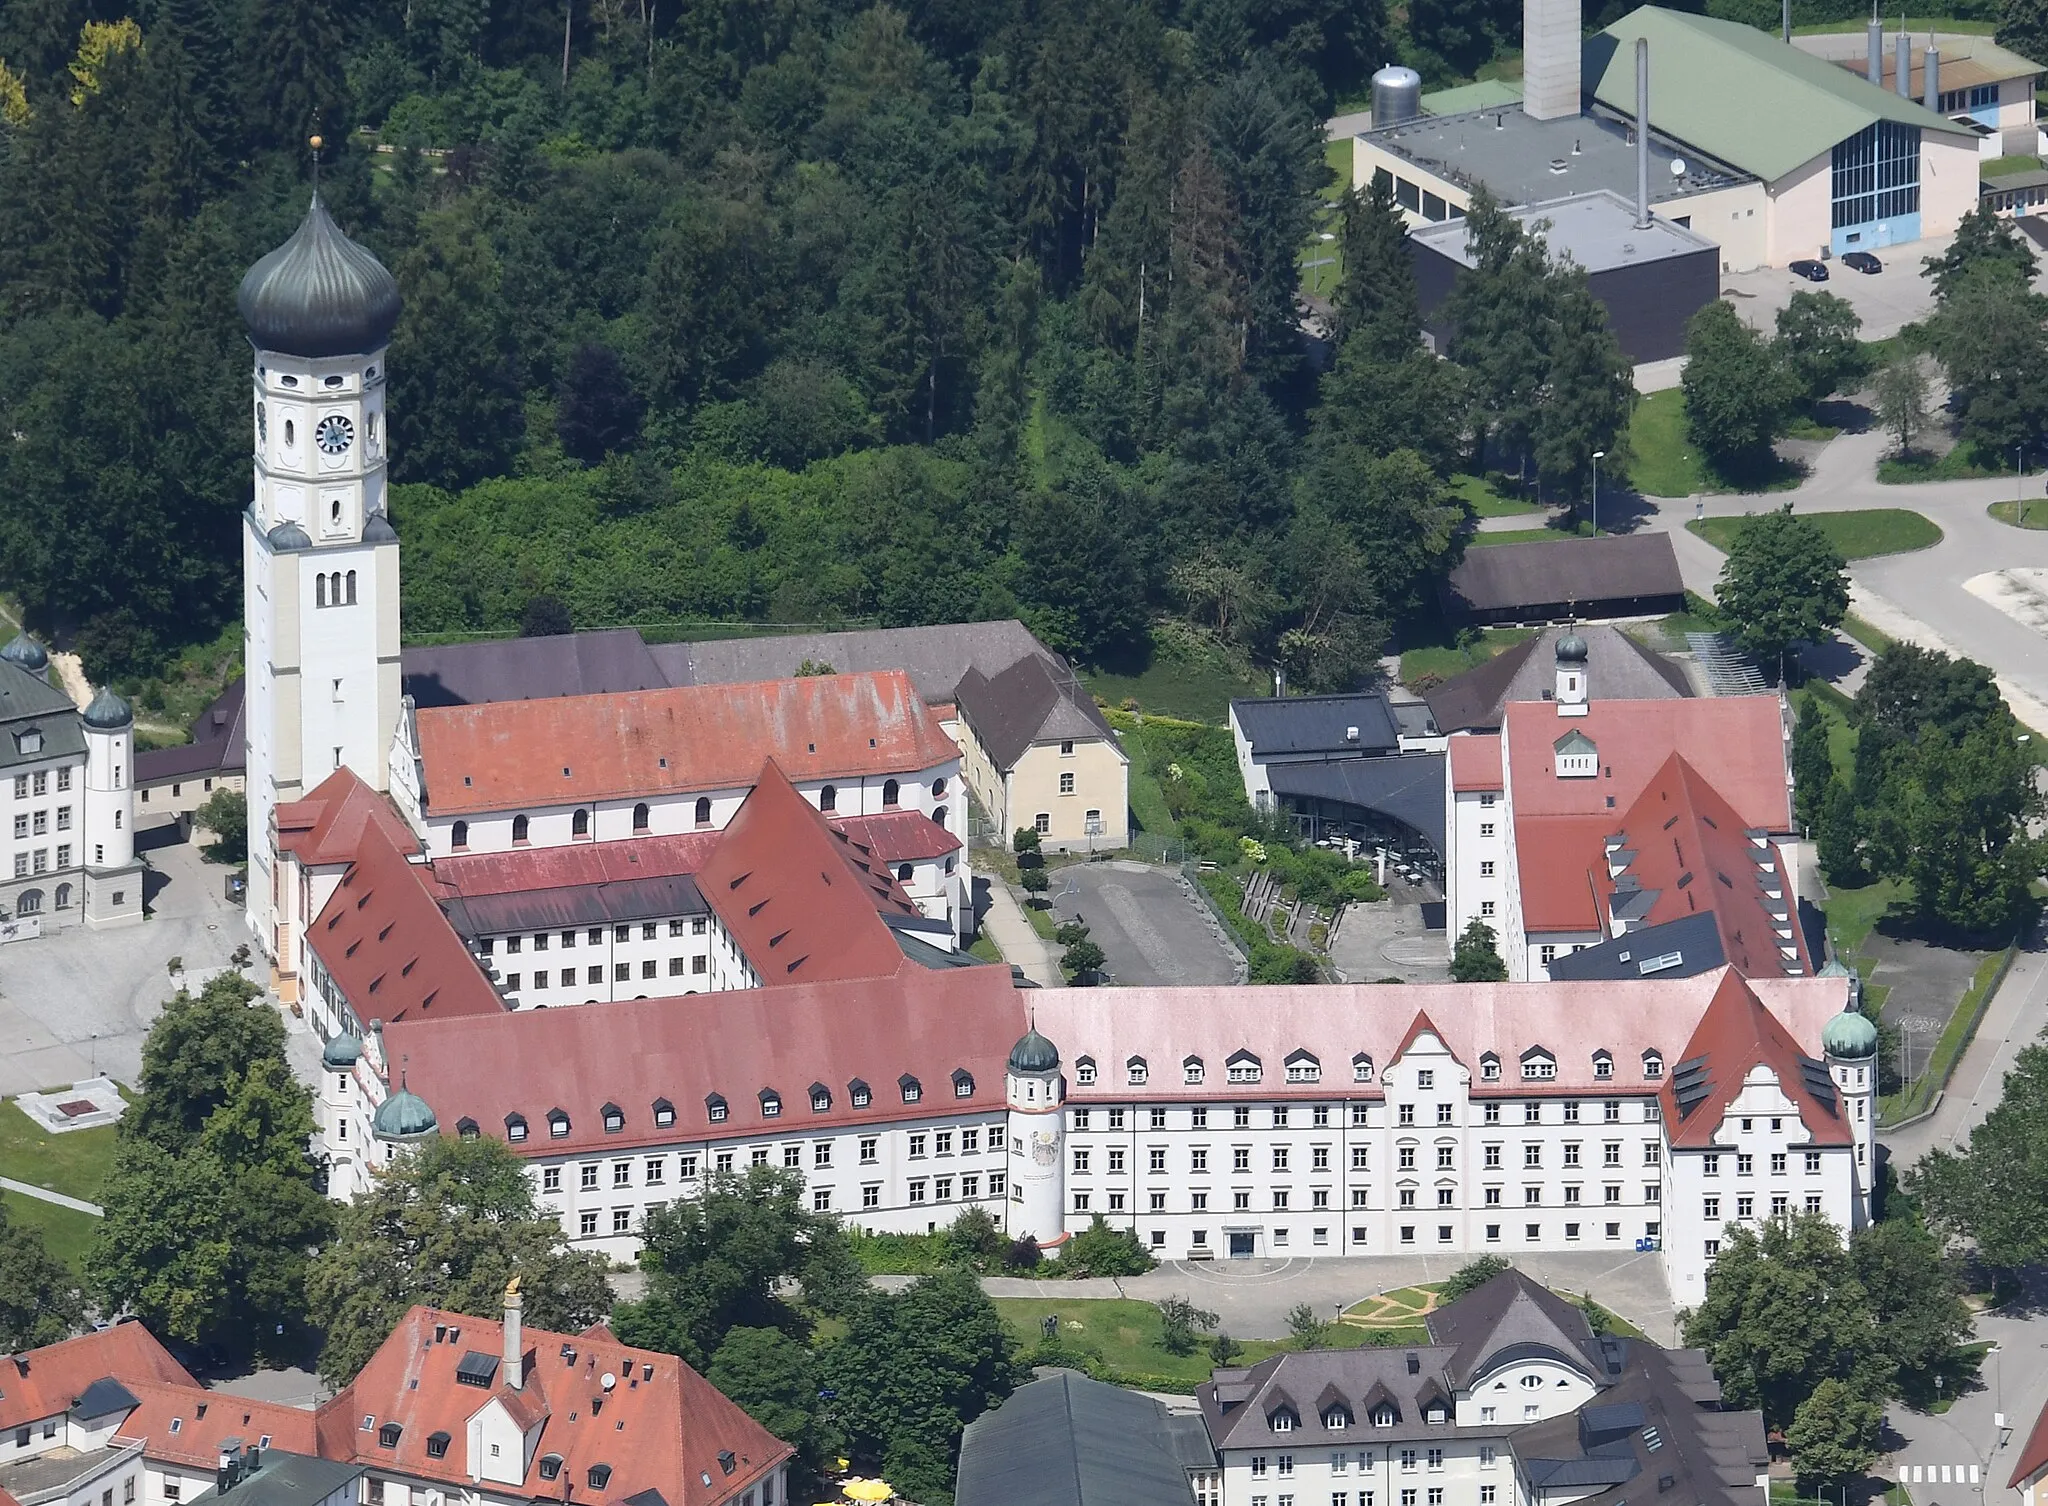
[385,959,1024,1156]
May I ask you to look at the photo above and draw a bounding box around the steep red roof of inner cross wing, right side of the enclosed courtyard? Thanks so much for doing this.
[696,766,920,984]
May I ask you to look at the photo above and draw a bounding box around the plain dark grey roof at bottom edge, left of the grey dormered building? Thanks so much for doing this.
[952,1371,1214,1506]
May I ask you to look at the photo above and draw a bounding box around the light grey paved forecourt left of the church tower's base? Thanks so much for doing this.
[0,832,248,1098]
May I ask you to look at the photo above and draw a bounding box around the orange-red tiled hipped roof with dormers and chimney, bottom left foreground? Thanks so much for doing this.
[319,1303,793,1506]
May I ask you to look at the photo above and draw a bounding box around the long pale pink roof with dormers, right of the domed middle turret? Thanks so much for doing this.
[1032,969,1847,1098]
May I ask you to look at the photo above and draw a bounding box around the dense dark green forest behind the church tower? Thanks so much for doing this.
[0,0,1632,684]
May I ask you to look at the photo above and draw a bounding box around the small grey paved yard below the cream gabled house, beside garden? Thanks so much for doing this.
[1047,861,1237,988]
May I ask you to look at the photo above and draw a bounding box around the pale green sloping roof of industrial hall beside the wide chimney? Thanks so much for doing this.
[1583,6,1976,182]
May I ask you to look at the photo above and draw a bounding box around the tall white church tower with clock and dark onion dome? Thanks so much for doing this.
[236,193,399,965]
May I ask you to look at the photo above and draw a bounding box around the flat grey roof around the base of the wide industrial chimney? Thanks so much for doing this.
[1358,104,1747,205]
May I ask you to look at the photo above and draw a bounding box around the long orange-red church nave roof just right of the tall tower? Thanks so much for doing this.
[418,670,961,815]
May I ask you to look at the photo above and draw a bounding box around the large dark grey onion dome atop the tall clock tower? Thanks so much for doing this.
[236,193,399,357]
